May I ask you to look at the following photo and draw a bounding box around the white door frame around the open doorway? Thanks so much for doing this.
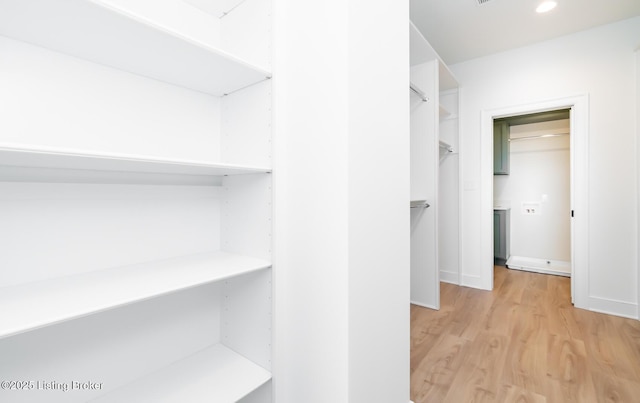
[480,94,589,308]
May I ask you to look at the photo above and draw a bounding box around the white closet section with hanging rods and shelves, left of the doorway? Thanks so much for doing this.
[410,23,461,309]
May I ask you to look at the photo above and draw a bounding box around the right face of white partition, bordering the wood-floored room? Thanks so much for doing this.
[348,0,410,403]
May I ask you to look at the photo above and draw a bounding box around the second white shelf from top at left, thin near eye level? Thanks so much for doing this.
[0,144,271,176]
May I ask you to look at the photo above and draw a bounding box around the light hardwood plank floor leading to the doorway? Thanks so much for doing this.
[411,266,640,403]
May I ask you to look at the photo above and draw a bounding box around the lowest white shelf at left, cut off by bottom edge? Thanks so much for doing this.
[92,344,271,403]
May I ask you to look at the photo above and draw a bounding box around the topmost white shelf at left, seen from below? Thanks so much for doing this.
[0,0,271,96]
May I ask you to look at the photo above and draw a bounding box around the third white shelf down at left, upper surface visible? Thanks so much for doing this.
[0,252,271,338]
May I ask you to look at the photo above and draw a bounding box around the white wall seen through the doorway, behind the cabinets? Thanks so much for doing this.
[493,120,571,262]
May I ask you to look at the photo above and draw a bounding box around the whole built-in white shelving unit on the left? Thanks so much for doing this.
[0,0,273,402]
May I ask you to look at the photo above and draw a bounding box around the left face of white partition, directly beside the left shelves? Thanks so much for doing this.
[273,0,349,403]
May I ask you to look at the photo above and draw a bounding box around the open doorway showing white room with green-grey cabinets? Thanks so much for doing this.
[493,109,571,277]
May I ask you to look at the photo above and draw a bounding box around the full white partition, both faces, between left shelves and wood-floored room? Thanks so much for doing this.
[274,0,409,403]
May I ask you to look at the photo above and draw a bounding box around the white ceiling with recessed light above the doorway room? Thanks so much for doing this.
[410,0,640,65]
